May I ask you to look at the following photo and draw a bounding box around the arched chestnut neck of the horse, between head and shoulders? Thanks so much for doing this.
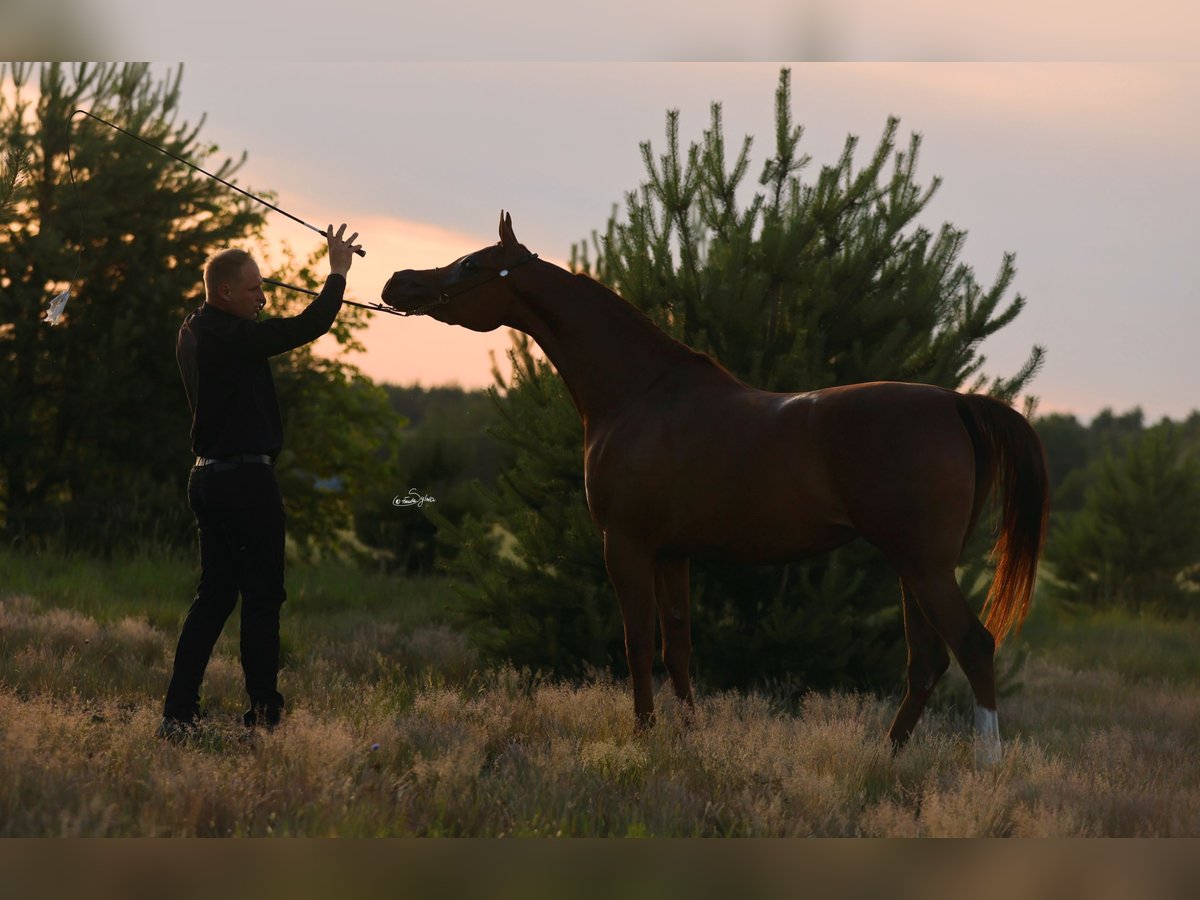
[509,263,696,425]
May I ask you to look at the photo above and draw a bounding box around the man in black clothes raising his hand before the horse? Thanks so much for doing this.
[158,224,359,739]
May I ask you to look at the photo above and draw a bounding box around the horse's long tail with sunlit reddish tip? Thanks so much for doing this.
[959,394,1050,644]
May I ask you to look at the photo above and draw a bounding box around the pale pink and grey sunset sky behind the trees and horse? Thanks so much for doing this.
[211,64,1200,419]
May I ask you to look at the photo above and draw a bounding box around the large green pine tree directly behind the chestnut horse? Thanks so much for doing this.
[446,70,1042,691]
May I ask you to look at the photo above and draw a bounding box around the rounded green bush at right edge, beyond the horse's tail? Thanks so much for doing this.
[1048,422,1200,612]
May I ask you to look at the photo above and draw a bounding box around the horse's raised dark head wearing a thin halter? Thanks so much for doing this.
[382,210,536,331]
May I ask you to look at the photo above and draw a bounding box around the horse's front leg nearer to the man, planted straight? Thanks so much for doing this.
[604,529,654,727]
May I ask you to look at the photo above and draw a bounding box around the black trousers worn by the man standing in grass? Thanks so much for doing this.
[163,463,287,724]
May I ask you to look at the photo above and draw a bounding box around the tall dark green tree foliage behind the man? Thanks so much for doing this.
[0,64,403,552]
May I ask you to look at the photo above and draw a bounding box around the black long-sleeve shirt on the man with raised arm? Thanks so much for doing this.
[175,275,346,458]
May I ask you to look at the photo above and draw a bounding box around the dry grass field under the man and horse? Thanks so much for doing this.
[0,553,1200,836]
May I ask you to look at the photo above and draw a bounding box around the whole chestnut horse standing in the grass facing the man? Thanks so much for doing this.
[383,212,1048,762]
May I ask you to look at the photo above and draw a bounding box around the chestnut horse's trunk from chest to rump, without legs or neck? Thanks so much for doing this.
[587,382,974,562]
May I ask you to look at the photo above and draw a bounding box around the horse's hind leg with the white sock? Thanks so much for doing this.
[901,569,1001,764]
